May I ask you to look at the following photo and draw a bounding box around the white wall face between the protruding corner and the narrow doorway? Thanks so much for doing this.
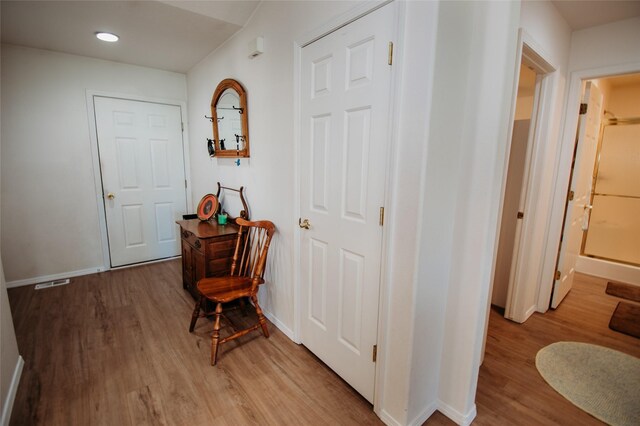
[432,2,520,424]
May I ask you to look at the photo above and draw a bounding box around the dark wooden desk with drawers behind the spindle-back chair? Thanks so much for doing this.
[176,219,238,298]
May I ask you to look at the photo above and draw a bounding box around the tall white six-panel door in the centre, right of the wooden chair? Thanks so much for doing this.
[300,4,395,401]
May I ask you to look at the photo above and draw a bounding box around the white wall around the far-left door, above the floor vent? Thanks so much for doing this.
[1,45,186,285]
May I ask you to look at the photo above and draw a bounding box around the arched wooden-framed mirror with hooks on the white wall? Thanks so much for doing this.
[211,78,249,158]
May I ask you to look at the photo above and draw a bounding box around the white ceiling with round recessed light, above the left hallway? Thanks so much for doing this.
[1,0,259,73]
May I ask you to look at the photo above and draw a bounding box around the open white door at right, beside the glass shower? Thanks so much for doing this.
[551,82,602,309]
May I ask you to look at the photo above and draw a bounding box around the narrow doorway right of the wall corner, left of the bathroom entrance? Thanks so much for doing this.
[490,39,555,323]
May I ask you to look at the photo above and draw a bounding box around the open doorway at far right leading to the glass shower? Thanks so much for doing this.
[551,74,640,308]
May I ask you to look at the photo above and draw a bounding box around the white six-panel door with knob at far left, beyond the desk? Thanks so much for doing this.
[93,96,187,266]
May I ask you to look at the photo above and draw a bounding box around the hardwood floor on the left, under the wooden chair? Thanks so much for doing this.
[9,260,382,426]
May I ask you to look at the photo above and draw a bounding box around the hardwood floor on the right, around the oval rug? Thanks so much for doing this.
[425,274,640,426]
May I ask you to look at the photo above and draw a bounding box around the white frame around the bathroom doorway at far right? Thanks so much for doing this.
[537,62,640,313]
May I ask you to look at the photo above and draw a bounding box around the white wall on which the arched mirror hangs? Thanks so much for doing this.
[187,1,364,335]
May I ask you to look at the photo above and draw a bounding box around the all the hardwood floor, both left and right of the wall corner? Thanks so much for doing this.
[9,260,640,425]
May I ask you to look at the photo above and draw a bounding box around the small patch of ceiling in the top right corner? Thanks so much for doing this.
[551,0,640,30]
